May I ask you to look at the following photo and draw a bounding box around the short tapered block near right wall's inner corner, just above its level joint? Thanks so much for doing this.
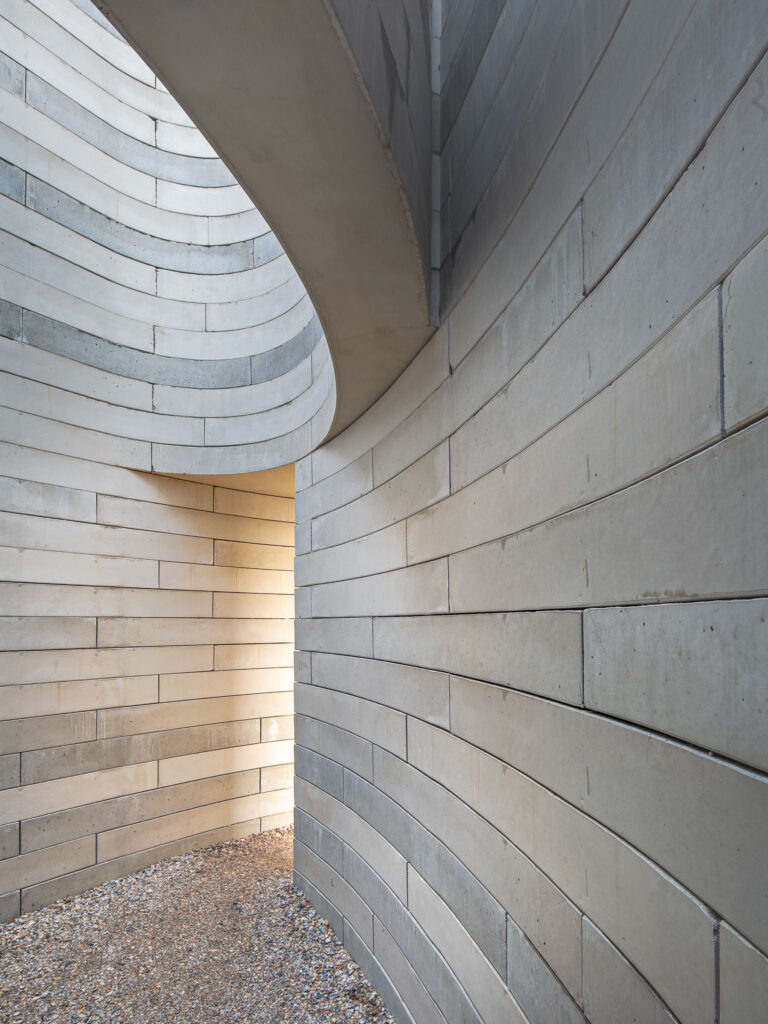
[309,558,449,617]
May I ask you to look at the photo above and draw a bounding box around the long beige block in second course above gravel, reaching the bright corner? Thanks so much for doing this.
[98,792,284,861]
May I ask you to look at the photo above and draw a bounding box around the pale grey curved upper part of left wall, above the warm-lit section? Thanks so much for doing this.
[0,0,335,473]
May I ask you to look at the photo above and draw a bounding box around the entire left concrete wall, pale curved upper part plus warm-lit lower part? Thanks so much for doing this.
[0,0,307,919]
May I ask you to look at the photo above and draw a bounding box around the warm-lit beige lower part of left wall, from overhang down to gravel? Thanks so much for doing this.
[0,460,294,920]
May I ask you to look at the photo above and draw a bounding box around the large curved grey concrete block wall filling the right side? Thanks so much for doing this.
[295,0,768,1024]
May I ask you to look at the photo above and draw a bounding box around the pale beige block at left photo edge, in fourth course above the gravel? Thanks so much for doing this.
[0,761,158,823]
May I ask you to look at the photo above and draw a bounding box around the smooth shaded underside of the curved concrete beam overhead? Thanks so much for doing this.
[93,0,432,435]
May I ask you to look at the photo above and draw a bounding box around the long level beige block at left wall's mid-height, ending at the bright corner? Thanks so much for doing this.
[98,609,293,647]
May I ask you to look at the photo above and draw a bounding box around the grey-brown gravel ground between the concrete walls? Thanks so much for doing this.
[0,828,394,1024]
